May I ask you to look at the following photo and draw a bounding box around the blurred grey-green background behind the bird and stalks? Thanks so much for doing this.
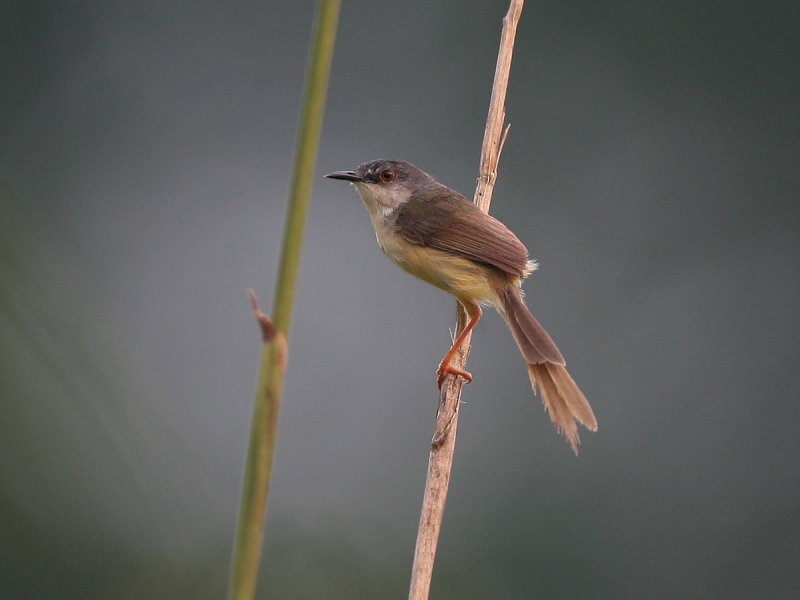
[0,0,800,600]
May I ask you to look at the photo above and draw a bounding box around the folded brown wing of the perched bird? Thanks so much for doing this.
[395,185,528,277]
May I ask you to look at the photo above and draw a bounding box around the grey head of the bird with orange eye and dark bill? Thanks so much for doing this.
[325,158,440,214]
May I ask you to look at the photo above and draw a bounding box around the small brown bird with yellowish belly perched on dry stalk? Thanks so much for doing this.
[325,159,597,454]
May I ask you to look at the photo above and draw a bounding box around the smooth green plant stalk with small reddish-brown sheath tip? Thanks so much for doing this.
[228,0,340,600]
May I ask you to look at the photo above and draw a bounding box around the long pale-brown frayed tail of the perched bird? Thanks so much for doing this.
[499,285,597,454]
